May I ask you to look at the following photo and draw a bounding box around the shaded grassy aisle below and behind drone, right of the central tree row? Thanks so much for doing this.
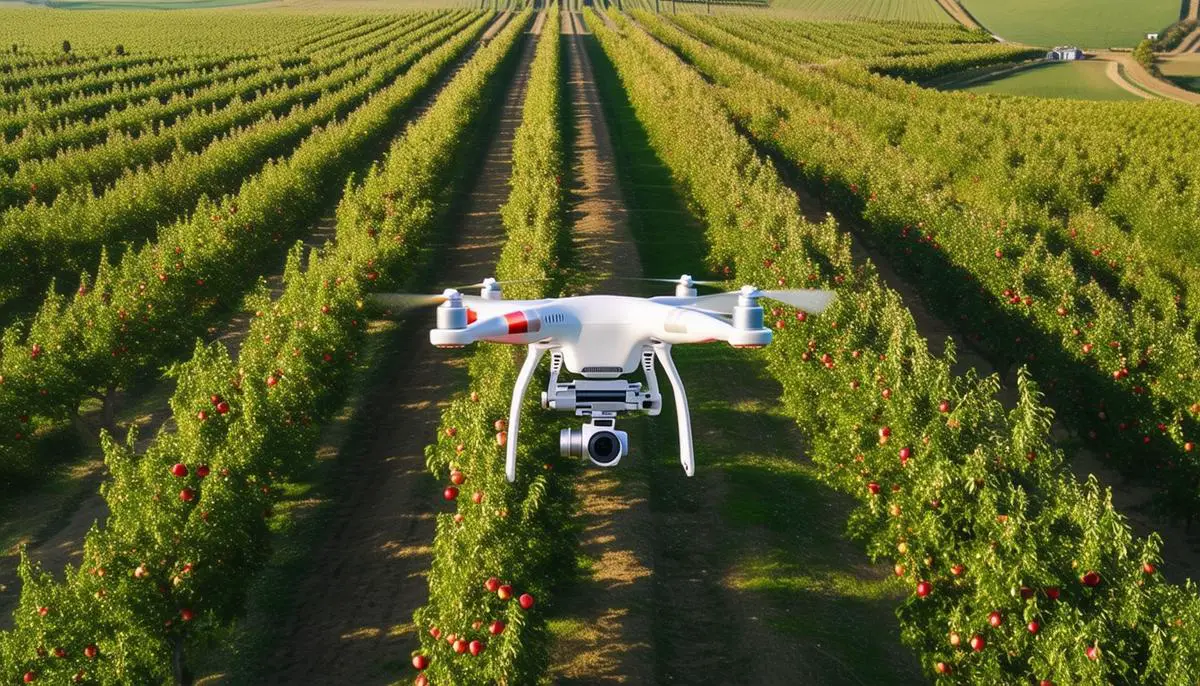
[551,13,918,686]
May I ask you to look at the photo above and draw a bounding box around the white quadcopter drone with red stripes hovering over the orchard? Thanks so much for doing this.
[374,275,834,481]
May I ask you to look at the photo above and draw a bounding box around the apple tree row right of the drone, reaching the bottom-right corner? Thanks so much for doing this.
[593,9,1200,685]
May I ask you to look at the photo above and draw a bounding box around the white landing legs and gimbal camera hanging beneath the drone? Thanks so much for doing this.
[504,342,696,482]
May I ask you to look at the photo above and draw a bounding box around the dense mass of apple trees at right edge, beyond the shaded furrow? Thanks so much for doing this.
[654,10,1200,517]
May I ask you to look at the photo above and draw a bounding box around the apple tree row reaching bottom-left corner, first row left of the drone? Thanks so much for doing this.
[0,16,511,684]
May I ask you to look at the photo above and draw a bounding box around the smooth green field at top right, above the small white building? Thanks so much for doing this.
[961,0,1180,48]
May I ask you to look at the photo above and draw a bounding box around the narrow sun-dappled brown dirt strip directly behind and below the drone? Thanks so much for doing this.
[551,11,654,684]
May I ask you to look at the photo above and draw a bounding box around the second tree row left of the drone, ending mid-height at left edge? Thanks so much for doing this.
[0,14,482,482]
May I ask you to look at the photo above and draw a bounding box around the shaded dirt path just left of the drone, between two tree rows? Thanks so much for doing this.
[269,16,535,685]
